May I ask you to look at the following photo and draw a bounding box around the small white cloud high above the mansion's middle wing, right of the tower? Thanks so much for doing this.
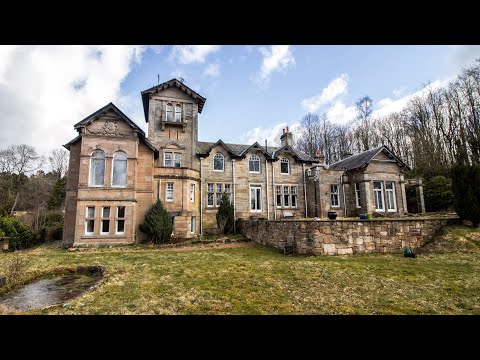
[254,45,295,86]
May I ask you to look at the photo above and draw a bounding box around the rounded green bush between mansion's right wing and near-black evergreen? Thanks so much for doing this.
[423,176,454,211]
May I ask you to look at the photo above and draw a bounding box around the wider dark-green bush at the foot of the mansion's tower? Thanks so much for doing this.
[139,200,173,243]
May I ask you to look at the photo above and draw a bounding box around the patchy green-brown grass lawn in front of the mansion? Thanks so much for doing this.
[0,227,480,314]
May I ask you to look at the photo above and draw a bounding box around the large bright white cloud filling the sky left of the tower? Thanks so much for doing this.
[0,46,145,163]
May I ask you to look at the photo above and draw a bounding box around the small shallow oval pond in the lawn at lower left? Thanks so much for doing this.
[0,274,100,311]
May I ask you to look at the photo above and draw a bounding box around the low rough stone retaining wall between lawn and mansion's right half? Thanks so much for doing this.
[237,217,459,255]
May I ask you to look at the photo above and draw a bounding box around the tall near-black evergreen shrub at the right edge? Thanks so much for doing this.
[452,165,480,225]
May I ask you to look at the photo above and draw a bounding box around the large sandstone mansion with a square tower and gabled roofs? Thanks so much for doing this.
[63,79,408,245]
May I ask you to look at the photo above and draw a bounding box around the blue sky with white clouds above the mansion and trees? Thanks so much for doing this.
[0,45,480,169]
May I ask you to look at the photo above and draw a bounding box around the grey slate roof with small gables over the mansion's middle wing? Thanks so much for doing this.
[197,140,316,162]
